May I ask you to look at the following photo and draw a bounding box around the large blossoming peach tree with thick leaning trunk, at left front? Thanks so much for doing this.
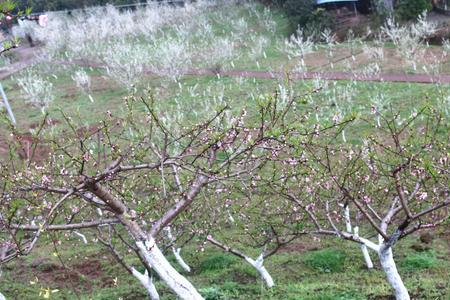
[0,88,320,299]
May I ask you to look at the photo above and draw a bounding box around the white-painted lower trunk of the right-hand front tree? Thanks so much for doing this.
[378,245,411,300]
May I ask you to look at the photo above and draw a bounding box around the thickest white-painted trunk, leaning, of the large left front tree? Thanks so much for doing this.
[136,238,203,300]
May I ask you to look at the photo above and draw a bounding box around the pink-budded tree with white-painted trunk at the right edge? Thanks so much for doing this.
[272,108,450,300]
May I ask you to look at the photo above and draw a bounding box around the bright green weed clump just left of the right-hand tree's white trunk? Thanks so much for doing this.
[305,249,345,273]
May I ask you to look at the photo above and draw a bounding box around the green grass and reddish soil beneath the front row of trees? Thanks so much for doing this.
[1,236,450,300]
